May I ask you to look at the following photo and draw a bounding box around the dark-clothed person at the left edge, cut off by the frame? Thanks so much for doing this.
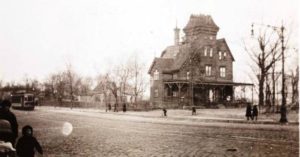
[0,100,18,146]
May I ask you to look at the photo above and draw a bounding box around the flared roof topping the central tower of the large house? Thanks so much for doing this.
[184,14,219,30]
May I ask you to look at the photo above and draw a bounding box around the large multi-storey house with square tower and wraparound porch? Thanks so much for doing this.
[148,15,252,108]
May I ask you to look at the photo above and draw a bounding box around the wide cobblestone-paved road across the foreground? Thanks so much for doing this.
[14,108,299,157]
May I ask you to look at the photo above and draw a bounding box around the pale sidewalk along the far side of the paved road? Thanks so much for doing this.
[36,106,299,125]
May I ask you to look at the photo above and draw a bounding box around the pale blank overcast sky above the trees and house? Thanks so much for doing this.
[0,0,299,82]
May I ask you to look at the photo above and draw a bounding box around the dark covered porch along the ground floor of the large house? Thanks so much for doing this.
[163,80,253,108]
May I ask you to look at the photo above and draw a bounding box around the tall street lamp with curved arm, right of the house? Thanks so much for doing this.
[251,23,288,123]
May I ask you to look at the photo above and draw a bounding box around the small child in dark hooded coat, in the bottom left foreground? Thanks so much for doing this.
[16,125,43,157]
